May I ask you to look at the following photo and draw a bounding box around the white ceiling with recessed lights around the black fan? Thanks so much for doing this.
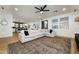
[0,5,79,23]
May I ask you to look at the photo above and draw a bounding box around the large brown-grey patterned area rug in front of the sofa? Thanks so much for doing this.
[8,37,71,54]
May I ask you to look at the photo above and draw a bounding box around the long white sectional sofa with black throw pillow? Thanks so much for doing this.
[19,30,54,43]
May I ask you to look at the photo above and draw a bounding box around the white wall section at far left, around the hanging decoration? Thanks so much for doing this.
[0,13,13,38]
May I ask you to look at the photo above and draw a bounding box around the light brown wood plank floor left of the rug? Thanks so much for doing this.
[0,33,19,54]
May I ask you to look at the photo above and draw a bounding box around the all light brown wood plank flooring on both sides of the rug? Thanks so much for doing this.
[0,33,79,54]
